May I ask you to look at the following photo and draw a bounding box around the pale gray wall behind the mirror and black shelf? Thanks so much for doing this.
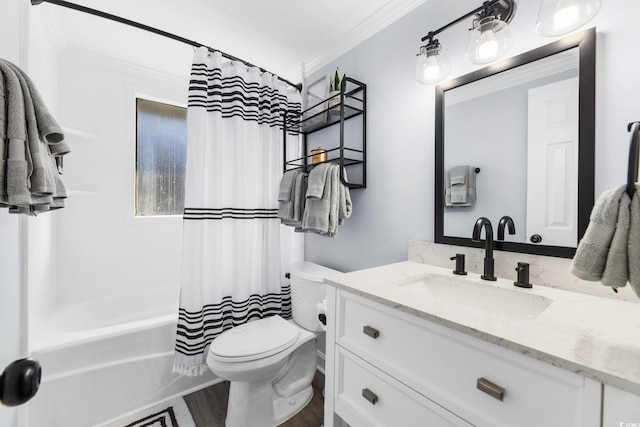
[305,0,640,271]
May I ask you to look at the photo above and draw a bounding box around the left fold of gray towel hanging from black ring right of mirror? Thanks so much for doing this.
[571,185,626,281]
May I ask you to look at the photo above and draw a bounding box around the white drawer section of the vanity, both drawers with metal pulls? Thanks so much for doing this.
[325,286,604,427]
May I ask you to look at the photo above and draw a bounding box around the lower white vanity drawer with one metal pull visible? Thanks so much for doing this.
[335,346,470,427]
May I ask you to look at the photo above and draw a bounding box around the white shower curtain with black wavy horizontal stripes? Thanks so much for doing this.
[174,48,301,376]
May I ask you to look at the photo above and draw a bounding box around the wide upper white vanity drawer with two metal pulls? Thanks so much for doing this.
[336,292,600,427]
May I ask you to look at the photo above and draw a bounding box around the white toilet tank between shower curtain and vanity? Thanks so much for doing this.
[289,261,342,332]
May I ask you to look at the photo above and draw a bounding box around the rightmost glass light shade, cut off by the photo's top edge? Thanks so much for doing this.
[536,0,602,37]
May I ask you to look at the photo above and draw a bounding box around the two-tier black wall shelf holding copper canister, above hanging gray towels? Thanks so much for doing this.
[283,77,367,189]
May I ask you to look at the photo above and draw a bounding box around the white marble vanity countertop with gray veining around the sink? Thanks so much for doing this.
[325,261,640,395]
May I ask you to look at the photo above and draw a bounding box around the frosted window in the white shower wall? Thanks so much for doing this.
[136,98,187,216]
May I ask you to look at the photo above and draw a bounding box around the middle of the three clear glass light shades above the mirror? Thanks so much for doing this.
[467,16,512,64]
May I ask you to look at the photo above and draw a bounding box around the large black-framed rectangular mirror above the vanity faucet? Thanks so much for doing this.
[435,28,596,258]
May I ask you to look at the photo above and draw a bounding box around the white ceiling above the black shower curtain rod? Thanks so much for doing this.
[34,0,425,81]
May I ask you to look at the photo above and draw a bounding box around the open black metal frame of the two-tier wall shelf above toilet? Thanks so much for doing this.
[283,77,367,189]
